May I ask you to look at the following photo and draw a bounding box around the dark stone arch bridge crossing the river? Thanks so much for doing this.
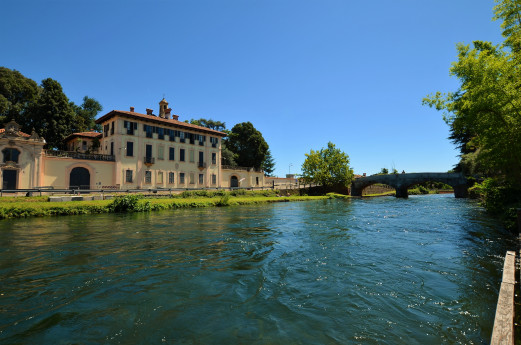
[351,173,468,198]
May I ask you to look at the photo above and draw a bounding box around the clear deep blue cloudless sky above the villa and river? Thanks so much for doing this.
[0,0,502,176]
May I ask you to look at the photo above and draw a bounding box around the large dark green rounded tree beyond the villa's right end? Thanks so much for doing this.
[225,122,269,169]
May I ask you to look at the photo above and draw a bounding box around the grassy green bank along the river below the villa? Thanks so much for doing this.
[0,191,328,219]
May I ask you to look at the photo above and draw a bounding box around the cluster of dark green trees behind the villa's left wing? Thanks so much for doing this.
[0,67,103,149]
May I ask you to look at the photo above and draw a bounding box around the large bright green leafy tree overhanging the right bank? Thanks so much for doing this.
[423,0,521,185]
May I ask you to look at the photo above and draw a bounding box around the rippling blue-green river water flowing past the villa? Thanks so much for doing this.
[0,195,515,344]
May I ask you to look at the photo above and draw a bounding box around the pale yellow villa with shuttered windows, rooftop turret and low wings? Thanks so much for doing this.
[0,99,265,190]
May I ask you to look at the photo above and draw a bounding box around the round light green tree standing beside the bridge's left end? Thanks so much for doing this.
[302,142,353,187]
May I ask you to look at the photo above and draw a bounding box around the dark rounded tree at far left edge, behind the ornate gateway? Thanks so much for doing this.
[0,67,39,124]
